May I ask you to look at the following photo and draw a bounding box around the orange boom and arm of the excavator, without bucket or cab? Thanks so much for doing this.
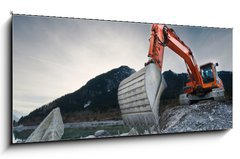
[148,24,202,92]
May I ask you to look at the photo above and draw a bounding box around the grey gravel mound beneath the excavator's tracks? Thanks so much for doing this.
[160,101,232,133]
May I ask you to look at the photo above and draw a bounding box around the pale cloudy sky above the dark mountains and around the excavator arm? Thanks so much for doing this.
[12,15,232,115]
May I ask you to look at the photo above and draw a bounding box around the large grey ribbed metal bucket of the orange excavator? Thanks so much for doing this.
[118,63,167,130]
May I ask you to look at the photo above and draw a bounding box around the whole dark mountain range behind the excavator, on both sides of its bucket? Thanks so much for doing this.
[18,66,232,125]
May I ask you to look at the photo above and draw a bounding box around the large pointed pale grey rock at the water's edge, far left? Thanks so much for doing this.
[26,108,64,142]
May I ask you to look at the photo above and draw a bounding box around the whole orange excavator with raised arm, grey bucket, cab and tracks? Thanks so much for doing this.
[118,24,224,130]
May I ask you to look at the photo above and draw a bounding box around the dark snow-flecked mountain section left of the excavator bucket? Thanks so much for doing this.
[18,66,135,125]
